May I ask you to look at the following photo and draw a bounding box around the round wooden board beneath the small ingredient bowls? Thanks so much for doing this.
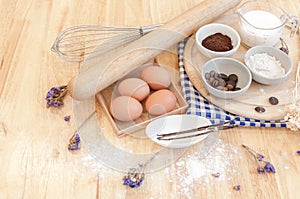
[184,14,300,120]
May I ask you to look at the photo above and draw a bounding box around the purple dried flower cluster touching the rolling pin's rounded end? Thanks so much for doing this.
[45,86,67,107]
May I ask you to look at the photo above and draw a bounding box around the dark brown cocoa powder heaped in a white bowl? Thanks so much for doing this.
[202,33,233,52]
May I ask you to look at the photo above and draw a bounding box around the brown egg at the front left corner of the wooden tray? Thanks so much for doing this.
[110,96,143,122]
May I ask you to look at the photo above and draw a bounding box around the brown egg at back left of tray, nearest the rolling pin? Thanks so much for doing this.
[118,78,150,101]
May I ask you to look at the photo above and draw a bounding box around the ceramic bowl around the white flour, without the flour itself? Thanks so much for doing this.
[244,46,292,85]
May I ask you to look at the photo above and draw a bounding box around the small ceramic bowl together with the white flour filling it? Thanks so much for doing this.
[244,46,292,85]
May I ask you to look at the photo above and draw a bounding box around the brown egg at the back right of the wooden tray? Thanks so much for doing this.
[141,66,171,90]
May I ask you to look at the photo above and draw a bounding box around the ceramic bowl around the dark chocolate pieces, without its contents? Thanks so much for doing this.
[201,57,252,99]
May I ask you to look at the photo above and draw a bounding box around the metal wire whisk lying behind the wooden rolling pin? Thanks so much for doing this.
[51,24,161,62]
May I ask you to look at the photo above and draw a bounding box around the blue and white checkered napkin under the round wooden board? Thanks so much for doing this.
[178,38,286,127]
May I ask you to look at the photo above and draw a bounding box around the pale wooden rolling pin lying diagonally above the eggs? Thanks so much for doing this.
[68,0,241,100]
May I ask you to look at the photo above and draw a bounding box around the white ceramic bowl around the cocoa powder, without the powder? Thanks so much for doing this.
[195,23,241,58]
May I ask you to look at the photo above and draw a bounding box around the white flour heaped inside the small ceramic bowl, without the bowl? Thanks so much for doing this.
[246,53,285,78]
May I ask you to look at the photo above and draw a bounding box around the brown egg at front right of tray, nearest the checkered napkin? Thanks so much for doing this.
[145,89,176,115]
